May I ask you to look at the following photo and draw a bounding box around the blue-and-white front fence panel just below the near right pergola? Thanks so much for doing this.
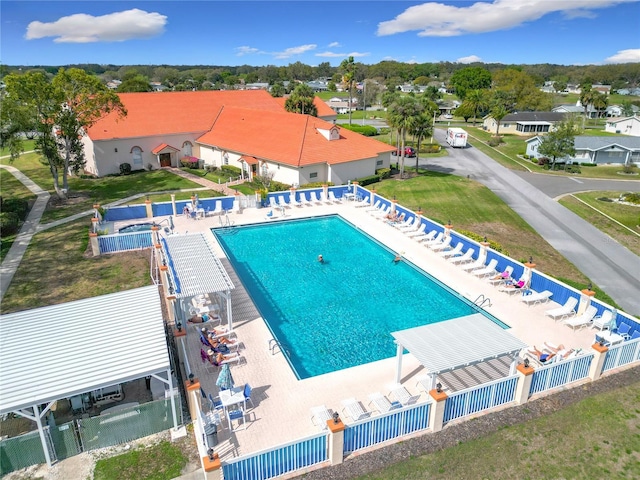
[443,375,518,423]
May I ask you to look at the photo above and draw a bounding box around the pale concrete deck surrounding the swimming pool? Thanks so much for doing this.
[161,202,594,460]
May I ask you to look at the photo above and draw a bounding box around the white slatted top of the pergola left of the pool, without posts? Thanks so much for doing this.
[163,233,235,298]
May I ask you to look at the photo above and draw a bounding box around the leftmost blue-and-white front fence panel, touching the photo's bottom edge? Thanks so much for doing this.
[222,431,328,480]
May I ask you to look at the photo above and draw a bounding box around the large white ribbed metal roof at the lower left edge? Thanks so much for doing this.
[0,286,171,414]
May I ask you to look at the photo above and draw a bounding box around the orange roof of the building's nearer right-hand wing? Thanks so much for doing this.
[197,107,394,167]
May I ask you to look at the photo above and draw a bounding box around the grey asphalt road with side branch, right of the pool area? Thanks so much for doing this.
[420,130,640,315]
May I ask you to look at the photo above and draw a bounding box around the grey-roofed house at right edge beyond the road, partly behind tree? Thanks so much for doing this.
[526,135,640,165]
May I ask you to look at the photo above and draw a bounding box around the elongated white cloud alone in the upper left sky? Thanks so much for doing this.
[25,8,167,43]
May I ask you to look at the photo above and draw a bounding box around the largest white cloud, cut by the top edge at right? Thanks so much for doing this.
[377,0,637,37]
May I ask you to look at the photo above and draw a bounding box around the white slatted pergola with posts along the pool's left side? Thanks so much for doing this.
[162,233,235,329]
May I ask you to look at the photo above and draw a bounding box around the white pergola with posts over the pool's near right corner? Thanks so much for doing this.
[391,313,527,387]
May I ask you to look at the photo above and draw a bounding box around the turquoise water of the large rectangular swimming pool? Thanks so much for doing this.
[212,215,484,379]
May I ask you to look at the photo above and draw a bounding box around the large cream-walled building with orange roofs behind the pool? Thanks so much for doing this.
[83,90,394,185]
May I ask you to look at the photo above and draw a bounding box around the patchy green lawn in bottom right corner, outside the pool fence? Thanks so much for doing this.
[358,383,640,480]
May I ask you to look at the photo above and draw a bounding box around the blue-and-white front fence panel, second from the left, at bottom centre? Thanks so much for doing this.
[343,403,431,454]
